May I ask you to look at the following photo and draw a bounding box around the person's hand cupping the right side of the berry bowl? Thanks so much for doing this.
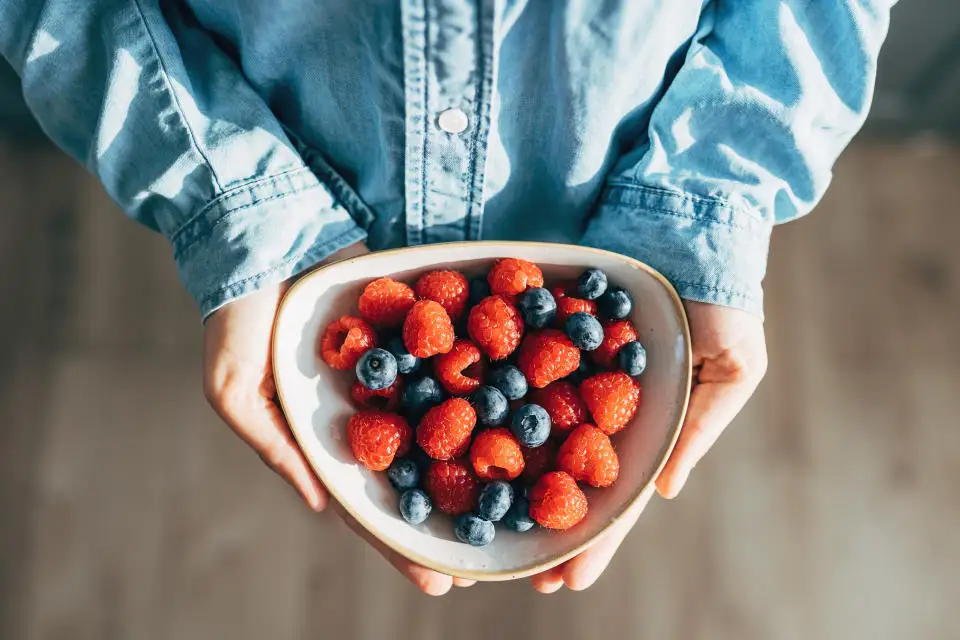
[531,302,767,593]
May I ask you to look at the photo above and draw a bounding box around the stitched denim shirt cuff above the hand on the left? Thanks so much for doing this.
[170,168,366,319]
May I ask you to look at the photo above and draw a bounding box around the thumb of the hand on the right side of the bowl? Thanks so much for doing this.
[656,380,757,498]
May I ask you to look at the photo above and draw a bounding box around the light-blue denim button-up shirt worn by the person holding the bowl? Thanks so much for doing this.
[0,0,892,315]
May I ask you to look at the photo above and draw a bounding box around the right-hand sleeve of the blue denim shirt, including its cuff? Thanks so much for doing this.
[583,0,893,315]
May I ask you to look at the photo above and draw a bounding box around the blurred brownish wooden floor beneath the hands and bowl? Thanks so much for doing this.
[0,143,960,640]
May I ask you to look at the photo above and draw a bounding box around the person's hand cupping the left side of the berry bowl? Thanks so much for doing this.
[203,244,473,595]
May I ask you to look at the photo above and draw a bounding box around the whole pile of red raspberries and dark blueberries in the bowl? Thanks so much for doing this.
[319,258,646,546]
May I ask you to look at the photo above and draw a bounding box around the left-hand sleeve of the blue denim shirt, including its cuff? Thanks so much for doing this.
[0,0,370,317]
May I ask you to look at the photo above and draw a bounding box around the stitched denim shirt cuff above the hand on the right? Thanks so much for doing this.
[583,183,773,317]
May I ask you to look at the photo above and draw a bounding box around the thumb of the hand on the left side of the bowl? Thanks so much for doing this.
[214,378,327,511]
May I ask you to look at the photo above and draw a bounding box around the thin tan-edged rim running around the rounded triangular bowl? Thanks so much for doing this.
[270,240,693,582]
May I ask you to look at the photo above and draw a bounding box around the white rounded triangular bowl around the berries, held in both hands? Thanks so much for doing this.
[273,242,691,580]
